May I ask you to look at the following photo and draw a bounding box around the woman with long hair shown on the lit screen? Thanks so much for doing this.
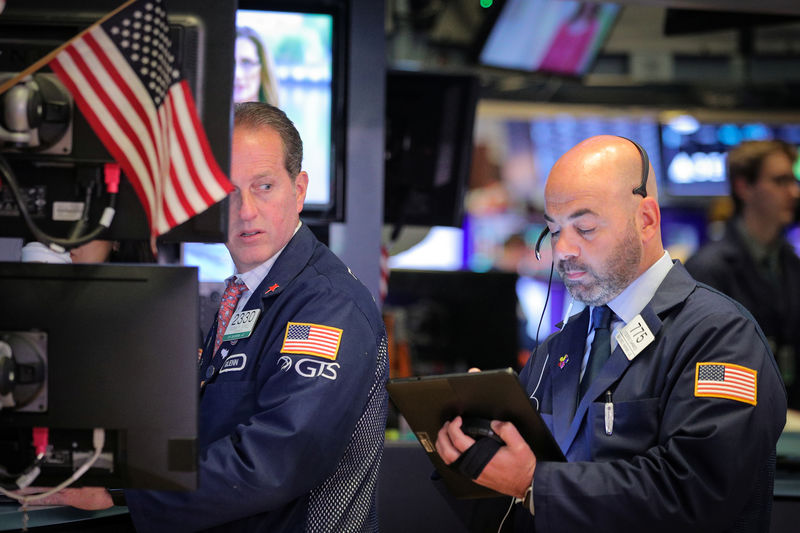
[233,26,278,106]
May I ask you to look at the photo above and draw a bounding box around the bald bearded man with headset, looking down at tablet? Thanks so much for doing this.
[436,136,786,533]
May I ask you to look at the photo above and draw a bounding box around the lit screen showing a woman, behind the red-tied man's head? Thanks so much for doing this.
[233,0,344,221]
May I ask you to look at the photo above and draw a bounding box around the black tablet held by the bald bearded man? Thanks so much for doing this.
[386,368,566,498]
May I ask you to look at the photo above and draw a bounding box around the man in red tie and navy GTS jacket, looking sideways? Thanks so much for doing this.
[43,103,388,532]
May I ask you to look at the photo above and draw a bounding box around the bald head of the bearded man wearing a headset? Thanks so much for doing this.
[545,135,664,305]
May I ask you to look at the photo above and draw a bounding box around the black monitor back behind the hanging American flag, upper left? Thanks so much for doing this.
[0,0,236,242]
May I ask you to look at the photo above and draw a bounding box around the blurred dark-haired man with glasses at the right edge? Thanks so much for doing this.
[686,141,800,409]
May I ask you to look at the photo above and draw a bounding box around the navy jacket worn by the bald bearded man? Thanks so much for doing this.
[450,263,786,533]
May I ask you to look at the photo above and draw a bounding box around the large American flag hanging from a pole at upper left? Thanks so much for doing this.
[50,0,233,235]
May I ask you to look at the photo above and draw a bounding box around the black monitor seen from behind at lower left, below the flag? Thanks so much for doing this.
[0,262,199,490]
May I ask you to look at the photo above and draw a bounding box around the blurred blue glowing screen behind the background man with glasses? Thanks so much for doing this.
[660,115,800,199]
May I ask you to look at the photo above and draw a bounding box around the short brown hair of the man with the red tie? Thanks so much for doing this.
[233,102,303,180]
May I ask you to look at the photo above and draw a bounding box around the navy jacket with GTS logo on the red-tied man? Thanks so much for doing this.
[126,225,388,532]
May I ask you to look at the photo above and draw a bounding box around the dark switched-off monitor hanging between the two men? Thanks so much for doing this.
[383,70,478,227]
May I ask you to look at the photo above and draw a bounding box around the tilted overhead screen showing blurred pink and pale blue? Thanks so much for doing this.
[479,0,620,76]
